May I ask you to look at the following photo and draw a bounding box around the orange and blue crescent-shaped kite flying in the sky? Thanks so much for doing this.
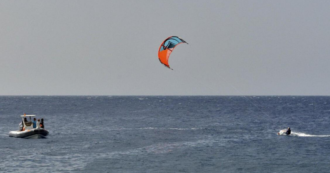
[158,36,188,69]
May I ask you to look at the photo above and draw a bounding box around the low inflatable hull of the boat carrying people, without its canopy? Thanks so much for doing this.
[9,129,48,138]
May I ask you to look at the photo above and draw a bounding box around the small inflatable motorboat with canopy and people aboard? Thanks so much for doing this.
[9,114,48,138]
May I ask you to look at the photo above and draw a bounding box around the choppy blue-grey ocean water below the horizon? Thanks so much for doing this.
[0,96,330,173]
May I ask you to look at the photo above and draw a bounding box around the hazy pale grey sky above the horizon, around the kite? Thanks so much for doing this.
[0,0,330,95]
